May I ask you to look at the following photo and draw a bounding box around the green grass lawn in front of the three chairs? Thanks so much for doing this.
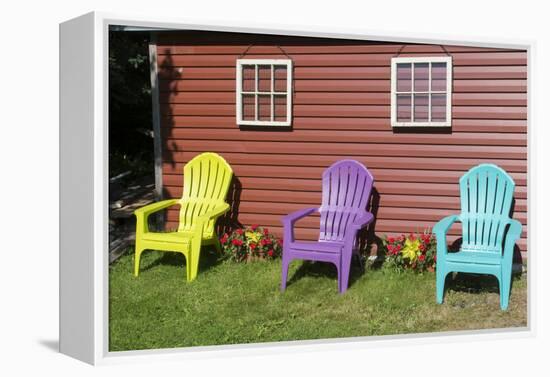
[109,250,527,351]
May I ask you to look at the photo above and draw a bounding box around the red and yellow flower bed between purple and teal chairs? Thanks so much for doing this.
[382,232,437,272]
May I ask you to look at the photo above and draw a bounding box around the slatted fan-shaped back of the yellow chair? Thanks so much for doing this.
[178,153,233,236]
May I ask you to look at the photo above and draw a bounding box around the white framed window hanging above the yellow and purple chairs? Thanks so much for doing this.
[237,59,292,126]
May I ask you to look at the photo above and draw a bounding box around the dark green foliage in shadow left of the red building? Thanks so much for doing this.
[109,30,153,177]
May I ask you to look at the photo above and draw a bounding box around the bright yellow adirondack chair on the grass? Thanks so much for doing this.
[134,153,233,281]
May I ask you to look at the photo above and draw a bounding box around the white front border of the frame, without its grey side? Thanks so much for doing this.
[60,12,536,364]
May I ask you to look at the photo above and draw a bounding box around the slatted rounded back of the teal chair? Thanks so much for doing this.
[460,164,515,253]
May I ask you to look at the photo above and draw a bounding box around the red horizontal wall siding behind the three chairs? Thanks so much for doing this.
[157,32,527,253]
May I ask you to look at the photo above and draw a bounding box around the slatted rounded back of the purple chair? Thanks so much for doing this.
[319,160,374,241]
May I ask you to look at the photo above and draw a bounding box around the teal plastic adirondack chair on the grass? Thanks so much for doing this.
[433,164,521,310]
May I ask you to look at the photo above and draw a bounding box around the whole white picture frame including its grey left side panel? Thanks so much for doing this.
[59,12,534,365]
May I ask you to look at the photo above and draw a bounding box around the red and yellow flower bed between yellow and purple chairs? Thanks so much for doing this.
[220,225,283,262]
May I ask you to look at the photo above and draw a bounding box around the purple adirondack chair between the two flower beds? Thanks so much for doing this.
[281,160,374,293]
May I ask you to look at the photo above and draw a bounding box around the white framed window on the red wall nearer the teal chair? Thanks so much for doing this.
[391,56,453,127]
